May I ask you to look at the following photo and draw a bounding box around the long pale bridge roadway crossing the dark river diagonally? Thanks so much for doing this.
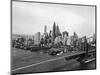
[11,50,95,73]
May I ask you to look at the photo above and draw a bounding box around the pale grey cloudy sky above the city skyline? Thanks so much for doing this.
[12,1,95,37]
